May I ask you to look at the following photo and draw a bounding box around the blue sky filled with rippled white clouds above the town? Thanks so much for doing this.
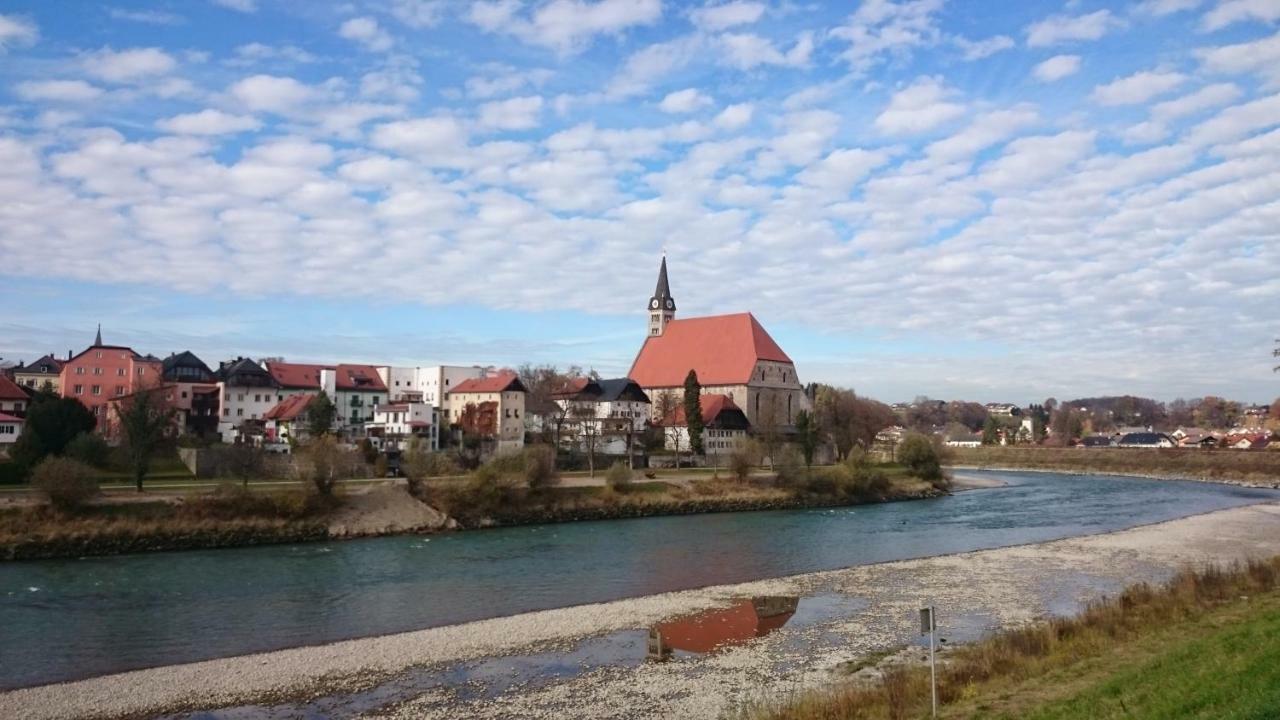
[0,0,1280,402]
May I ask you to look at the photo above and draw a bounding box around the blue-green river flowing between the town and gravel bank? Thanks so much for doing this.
[0,473,1280,689]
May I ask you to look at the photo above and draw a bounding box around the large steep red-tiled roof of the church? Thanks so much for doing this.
[627,313,791,387]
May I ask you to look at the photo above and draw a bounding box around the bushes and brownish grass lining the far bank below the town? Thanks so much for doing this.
[0,437,948,560]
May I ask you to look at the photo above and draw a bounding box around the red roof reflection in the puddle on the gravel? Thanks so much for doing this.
[648,596,800,660]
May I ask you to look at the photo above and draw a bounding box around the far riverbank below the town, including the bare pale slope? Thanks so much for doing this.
[0,473,946,560]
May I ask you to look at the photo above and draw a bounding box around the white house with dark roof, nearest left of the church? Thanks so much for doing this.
[552,378,652,455]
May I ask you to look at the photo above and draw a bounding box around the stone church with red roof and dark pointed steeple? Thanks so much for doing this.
[628,255,808,432]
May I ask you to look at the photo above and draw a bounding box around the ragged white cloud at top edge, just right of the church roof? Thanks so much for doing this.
[831,0,942,72]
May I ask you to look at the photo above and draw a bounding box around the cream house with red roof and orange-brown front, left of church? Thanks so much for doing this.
[445,370,526,452]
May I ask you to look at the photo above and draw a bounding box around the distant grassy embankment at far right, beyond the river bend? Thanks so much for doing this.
[950,446,1280,487]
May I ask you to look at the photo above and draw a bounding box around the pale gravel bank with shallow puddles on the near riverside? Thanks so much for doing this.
[0,502,1280,719]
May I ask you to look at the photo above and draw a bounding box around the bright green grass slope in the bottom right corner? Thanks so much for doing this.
[943,593,1280,720]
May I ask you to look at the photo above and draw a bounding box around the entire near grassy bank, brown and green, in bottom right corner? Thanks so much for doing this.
[742,557,1280,720]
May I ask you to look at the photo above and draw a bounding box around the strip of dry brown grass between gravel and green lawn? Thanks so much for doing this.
[740,556,1280,720]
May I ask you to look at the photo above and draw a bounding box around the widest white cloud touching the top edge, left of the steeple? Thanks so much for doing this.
[466,0,662,54]
